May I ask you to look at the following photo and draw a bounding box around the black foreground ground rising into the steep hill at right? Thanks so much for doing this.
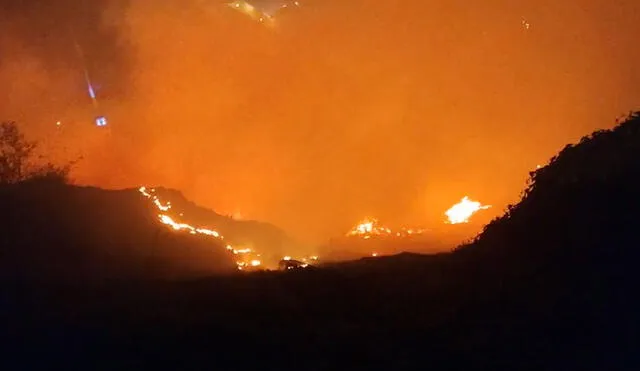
[0,115,640,371]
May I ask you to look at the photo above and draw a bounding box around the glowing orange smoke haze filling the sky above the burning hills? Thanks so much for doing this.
[0,0,640,246]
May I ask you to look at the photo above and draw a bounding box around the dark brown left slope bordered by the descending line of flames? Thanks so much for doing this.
[0,180,235,281]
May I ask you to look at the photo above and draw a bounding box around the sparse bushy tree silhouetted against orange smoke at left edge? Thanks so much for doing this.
[0,121,73,184]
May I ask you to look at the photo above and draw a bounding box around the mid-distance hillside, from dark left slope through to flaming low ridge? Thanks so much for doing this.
[0,170,496,278]
